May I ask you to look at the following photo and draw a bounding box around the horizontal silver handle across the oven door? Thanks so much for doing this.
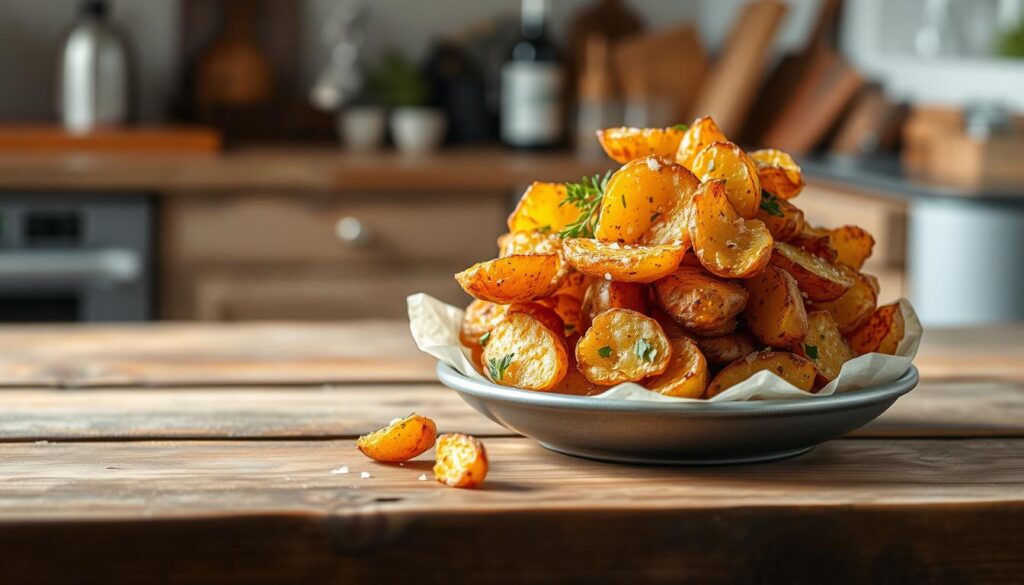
[0,248,142,288]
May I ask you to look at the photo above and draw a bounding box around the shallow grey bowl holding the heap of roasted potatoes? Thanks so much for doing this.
[437,364,918,465]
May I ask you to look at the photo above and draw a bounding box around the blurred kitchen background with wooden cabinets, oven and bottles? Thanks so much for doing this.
[0,0,1024,325]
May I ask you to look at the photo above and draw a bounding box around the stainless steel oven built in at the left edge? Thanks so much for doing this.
[0,193,154,323]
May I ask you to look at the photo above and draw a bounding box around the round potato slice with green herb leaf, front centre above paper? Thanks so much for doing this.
[575,308,672,385]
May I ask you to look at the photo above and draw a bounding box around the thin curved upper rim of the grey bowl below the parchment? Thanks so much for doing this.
[436,362,921,417]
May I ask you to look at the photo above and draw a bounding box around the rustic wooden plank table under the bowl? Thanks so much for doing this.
[0,323,1024,584]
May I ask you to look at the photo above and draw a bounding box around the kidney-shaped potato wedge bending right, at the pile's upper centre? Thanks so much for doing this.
[689,180,772,279]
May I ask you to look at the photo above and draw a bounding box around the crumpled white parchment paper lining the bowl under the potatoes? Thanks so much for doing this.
[408,293,922,402]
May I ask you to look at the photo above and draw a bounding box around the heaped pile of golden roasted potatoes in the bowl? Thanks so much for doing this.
[456,118,904,398]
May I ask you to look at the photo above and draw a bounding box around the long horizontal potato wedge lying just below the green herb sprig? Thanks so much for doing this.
[562,238,686,283]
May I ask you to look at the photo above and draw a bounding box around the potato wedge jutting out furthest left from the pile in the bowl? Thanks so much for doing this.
[455,254,561,304]
